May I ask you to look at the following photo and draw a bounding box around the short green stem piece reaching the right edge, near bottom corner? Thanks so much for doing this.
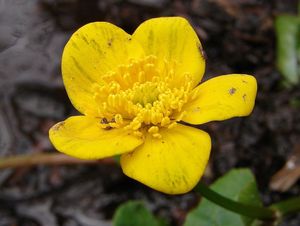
[270,197,300,217]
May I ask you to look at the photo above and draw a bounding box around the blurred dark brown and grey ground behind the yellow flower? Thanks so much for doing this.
[0,0,300,226]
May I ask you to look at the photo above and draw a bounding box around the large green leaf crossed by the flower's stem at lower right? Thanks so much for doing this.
[184,169,262,226]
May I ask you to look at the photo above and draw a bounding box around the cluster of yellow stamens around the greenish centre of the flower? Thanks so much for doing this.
[93,56,191,138]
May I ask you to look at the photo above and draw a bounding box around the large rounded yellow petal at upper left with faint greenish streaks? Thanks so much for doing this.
[62,22,143,116]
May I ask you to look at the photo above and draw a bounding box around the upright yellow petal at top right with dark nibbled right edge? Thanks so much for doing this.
[132,17,205,86]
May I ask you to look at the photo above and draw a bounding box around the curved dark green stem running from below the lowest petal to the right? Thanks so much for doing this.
[196,182,278,221]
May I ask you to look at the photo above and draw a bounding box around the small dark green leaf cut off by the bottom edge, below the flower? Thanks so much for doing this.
[113,201,162,226]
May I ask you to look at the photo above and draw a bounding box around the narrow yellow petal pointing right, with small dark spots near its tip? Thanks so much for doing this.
[182,74,257,124]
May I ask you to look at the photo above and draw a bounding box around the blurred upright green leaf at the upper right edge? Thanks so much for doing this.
[275,15,300,86]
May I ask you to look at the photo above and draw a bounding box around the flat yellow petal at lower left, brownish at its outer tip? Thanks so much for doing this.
[49,116,143,159]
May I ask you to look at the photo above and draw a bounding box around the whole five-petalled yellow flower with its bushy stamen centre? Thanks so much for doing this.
[49,17,257,194]
